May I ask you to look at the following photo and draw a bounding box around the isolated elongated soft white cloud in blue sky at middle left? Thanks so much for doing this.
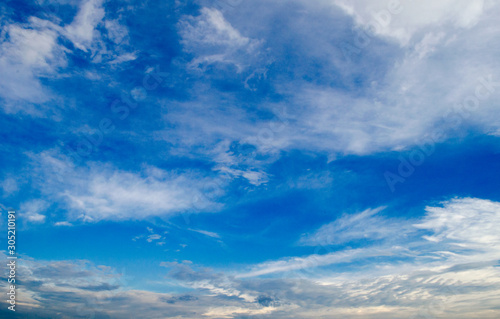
[28,152,223,221]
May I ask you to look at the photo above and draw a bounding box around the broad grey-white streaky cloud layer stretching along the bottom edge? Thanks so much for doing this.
[2,198,500,318]
